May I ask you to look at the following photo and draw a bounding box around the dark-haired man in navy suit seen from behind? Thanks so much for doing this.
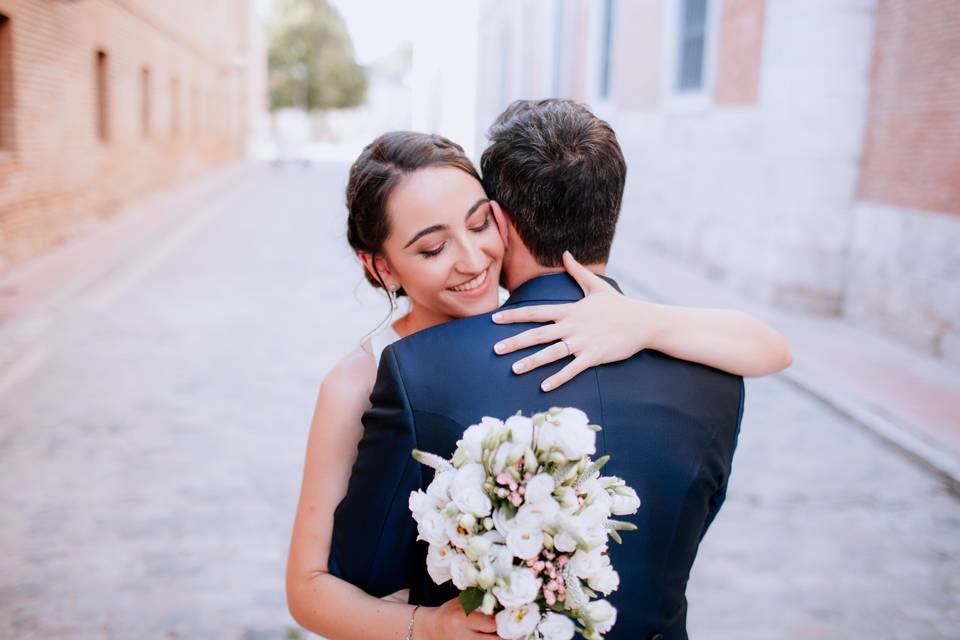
[330,100,743,640]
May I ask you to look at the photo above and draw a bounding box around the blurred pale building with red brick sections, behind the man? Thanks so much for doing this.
[414,0,960,363]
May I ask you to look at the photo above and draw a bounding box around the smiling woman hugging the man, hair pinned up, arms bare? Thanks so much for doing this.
[286,132,790,640]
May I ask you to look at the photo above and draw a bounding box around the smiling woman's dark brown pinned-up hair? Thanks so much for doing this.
[347,131,480,295]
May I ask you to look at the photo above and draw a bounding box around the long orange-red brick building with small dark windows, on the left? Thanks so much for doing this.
[0,0,252,272]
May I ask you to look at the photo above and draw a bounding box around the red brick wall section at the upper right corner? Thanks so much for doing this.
[859,0,960,214]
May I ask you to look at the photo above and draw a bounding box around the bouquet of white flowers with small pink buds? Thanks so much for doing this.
[410,408,640,640]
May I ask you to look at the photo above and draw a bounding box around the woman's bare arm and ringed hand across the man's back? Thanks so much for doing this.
[494,253,792,391]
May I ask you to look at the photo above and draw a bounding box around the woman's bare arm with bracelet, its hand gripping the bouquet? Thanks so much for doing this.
[286,353,495,640]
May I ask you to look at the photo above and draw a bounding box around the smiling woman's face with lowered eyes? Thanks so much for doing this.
[384,167,503,318]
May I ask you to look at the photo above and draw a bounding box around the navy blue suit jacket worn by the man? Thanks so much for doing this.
[330,274,743,640]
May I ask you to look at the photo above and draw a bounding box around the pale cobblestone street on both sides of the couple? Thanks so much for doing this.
[0,164,960,640]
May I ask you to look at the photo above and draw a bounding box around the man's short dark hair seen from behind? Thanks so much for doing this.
[480,99,627,267]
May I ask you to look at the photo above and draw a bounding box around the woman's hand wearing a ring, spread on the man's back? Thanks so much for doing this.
[493,251,663,391]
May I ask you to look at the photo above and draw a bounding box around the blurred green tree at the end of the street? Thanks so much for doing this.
[268,0,367,111]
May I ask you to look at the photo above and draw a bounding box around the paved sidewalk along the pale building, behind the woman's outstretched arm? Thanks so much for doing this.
[611,229,960,495]
